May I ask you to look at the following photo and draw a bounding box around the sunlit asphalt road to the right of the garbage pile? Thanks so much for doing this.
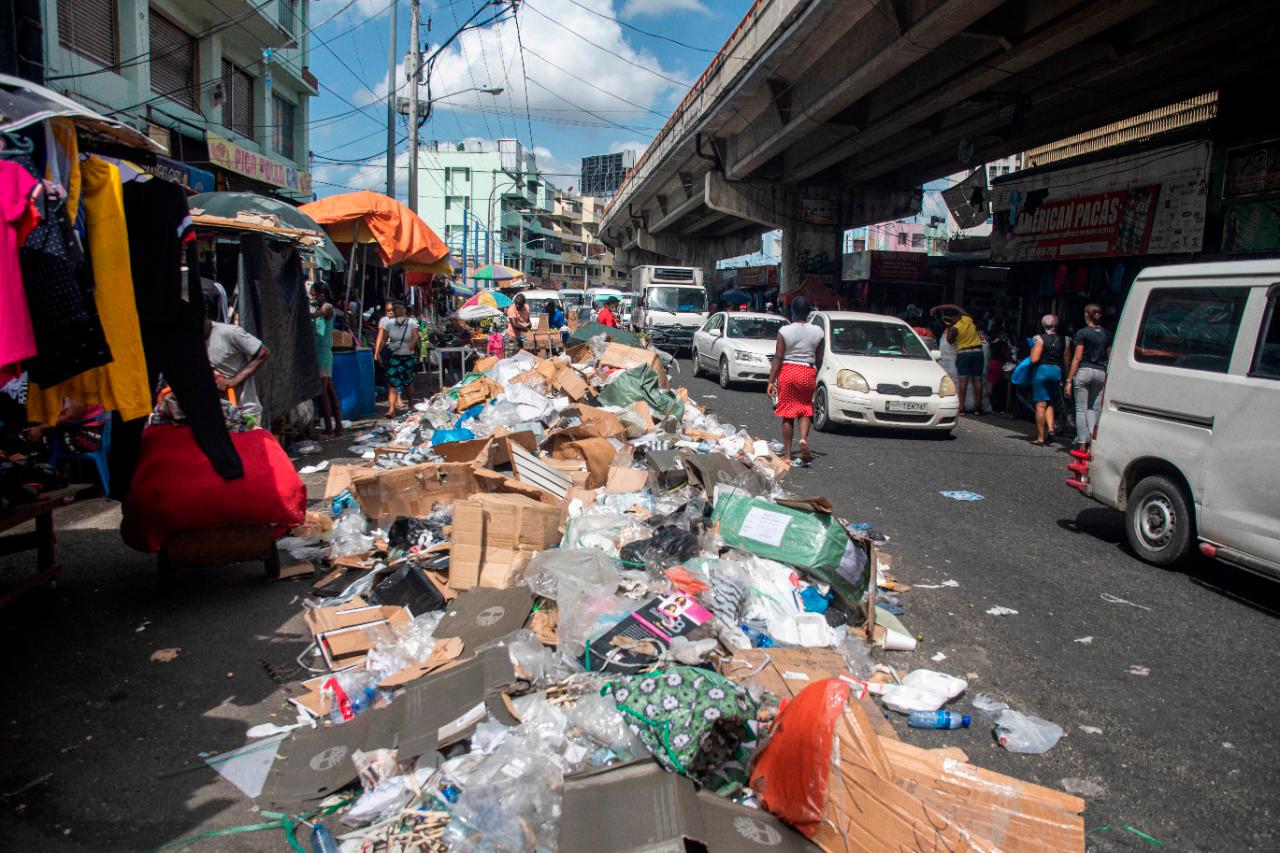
[681,361,1280,850]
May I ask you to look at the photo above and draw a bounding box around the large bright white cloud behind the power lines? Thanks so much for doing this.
[351,0,686,134]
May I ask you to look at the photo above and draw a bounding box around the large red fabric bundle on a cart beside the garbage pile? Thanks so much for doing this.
[120,425,307,553]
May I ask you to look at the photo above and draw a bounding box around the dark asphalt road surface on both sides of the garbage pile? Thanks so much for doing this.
[0,376,1280,853]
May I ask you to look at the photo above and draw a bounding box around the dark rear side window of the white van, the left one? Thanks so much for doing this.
[1133,287,1249,373]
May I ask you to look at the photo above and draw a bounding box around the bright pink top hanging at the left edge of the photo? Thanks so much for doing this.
[0,160,40,366]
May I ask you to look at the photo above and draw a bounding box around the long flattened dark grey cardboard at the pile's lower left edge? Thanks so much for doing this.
[259,647,516,813]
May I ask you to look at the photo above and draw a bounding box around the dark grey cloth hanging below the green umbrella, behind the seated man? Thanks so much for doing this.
[237,233,320,420]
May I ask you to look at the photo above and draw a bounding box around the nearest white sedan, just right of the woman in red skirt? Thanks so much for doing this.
[809,311,960,432]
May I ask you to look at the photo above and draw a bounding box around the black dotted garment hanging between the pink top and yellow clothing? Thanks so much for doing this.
[19,156,111,388]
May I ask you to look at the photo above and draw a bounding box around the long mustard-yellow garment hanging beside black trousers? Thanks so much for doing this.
[27,158,151,425]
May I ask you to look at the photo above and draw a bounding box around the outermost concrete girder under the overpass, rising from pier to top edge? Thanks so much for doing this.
[726,0,1002,181]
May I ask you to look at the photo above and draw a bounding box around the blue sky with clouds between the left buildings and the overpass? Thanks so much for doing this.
[310,0,751,200]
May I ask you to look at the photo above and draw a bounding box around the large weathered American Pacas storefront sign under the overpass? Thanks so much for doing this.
[991,142,1210,261]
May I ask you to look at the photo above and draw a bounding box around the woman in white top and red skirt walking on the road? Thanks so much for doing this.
[769,296,826,467]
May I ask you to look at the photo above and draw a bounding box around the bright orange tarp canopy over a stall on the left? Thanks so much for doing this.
[300,190,453,275]
